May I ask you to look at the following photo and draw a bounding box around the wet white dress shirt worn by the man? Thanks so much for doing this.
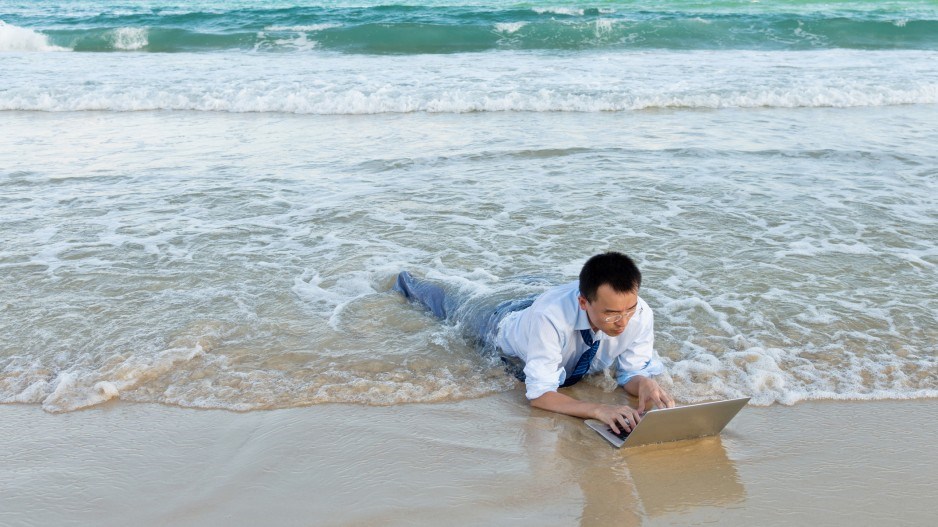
[496,281,664,399]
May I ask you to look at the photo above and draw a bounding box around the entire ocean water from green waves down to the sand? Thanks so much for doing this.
[0,1,938,412]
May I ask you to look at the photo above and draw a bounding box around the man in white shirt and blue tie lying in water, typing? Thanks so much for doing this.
[394,252,674,433]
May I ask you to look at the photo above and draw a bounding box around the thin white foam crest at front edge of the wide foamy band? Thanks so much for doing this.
[0,83,938,113]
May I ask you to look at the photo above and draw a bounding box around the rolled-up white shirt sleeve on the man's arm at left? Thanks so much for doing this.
[524,314,566,400]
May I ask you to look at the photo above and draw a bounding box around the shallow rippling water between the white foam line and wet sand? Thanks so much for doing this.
[0,106,938,410]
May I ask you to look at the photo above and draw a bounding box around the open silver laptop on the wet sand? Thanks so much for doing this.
[586,397,749,448]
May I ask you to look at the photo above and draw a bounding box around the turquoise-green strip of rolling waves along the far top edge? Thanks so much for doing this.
[0,2,938,54]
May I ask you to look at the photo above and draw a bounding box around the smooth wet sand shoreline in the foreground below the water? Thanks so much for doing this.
[0,386,938,526]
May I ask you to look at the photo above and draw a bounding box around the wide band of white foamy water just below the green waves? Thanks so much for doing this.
[0,47,938,115]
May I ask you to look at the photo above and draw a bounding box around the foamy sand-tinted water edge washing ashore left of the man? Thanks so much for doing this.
[0,330,515,413]
